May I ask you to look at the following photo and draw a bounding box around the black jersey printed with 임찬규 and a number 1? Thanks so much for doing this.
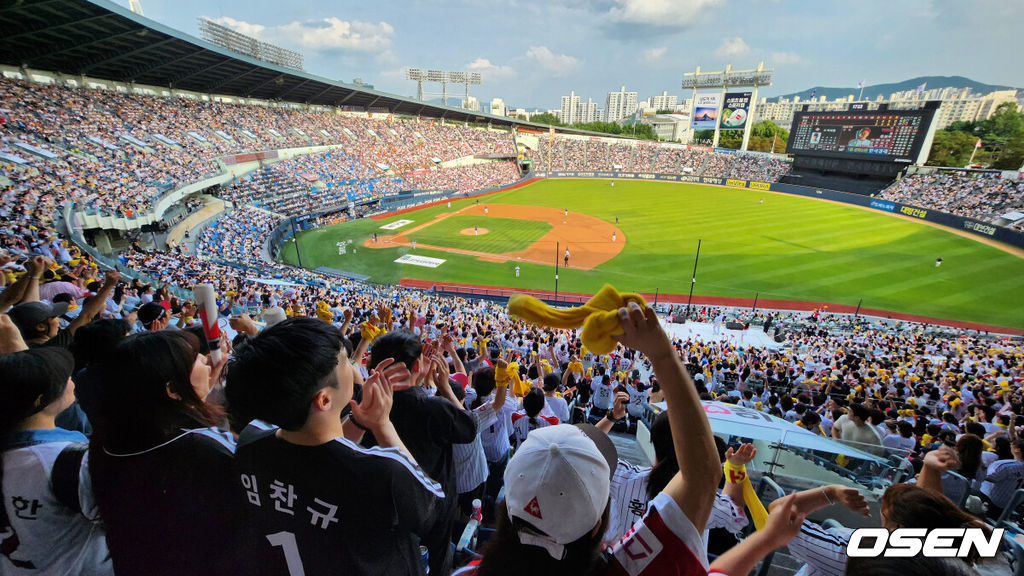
[236,423,444,576]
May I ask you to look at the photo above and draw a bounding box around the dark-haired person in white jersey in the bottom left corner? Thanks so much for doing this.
[0,346,114,575]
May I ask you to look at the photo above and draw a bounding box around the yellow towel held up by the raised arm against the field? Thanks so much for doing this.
[509,284,647,356]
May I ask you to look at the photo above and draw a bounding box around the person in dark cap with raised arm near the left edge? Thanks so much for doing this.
[7,270,121,348]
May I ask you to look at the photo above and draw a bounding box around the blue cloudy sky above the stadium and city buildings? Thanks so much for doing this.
[115,0,1024,110]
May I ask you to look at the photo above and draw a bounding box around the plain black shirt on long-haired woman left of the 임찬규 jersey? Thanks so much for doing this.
[89,428,243,576]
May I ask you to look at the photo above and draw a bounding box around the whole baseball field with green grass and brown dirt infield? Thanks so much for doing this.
[283,179,1024,331]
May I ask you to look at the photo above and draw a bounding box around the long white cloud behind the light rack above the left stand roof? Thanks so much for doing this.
[212,16,394,52]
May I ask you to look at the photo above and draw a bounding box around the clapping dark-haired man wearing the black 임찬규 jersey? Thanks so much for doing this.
[226,318,444,576]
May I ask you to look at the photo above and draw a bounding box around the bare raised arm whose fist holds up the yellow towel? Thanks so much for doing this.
[617,302,722,533]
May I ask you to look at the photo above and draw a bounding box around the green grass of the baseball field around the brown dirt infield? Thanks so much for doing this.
[285,179,1024,328]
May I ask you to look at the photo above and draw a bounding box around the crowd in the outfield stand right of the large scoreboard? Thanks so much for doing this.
[881,172,1024,230]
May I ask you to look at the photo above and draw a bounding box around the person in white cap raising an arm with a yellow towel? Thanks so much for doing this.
[457,302,802,576]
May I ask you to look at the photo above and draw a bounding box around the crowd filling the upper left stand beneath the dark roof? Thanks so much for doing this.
[0,78,515,216]
